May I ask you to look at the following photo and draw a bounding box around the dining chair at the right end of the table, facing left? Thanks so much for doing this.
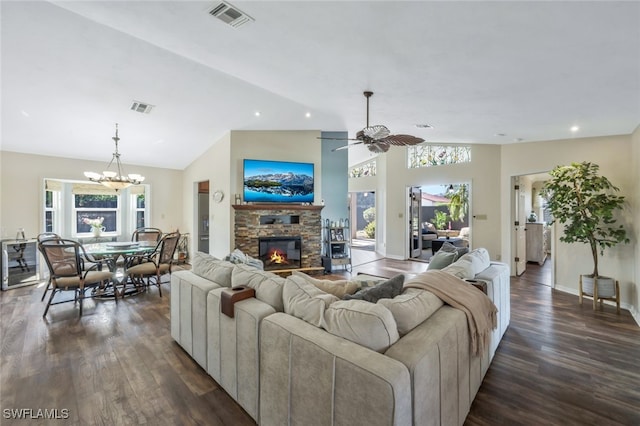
[123,232,180,297]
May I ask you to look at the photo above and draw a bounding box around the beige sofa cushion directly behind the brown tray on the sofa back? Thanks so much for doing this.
[231,265,285,312]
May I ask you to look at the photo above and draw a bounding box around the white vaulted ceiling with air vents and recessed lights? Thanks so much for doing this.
[0,1,640,169]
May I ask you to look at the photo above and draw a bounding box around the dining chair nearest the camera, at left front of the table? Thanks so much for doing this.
[38,238,117,317]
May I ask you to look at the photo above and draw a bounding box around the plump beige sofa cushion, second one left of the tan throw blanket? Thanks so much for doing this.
[322,300,400,352]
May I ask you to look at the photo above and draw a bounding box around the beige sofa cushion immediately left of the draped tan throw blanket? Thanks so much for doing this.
[378,288,443,336]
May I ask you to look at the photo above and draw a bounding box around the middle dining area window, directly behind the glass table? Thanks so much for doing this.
[73,193,121,235]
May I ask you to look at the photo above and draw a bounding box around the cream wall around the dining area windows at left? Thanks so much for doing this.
[0,151,183,238]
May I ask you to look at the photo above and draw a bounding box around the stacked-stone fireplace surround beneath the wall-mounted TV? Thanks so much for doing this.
[233,204,323,270]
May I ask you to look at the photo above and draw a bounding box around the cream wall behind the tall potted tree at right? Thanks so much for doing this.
[500,135,638,308]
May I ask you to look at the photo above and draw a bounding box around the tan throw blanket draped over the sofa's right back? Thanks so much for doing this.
[404,270,498,356]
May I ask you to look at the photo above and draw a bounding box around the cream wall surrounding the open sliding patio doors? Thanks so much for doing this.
[349,145,501,259]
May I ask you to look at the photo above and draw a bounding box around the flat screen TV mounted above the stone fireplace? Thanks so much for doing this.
[243,159,313,204]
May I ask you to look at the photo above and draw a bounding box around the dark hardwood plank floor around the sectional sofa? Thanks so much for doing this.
[0,258,640,425]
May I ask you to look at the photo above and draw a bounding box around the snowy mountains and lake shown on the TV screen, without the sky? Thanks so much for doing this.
[244,173,313,200]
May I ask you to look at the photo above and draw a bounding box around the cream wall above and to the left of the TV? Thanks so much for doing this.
[182,130,322,257]
